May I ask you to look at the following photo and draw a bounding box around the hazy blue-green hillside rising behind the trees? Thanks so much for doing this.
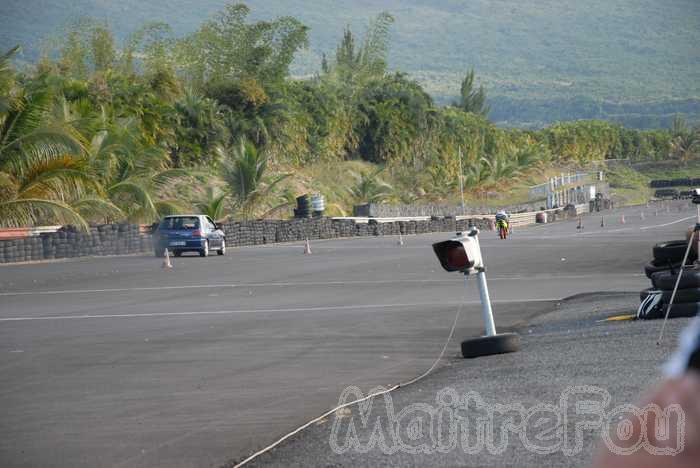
[0,0,700,128]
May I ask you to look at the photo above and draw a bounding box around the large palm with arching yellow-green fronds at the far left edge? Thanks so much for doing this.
[0,55,98,228]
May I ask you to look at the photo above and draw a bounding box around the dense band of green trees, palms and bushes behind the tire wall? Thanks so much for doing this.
[0,4,700,226]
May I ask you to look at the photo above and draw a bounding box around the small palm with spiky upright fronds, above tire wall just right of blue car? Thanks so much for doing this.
[222,139,290,219]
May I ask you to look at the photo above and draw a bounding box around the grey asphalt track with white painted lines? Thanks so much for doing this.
[0,205,694,467]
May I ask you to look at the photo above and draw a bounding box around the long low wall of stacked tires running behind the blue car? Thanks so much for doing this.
[0,216,490,263]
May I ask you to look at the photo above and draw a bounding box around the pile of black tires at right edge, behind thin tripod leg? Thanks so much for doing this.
[639,240,700,319]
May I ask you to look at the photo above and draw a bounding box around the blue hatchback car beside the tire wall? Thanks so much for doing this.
[154,215,226,257]
